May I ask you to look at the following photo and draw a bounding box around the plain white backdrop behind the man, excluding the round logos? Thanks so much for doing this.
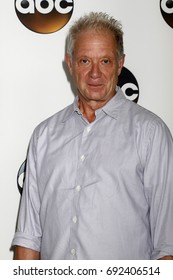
[0,0,173,260]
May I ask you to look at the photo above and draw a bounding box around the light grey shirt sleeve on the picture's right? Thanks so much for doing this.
[144,120,173,259]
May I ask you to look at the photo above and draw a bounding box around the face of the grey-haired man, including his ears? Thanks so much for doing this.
[66,31,124,103]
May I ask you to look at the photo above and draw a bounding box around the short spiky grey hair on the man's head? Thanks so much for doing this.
[66,12,124,59]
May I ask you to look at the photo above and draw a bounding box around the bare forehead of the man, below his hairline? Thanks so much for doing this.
[74,30,117,53]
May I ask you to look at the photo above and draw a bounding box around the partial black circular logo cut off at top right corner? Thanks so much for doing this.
[160,0,173,28]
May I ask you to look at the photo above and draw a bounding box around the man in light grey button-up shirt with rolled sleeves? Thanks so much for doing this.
[13,13,173,259]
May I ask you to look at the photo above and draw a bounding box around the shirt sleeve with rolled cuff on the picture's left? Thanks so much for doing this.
[12,129,42,251]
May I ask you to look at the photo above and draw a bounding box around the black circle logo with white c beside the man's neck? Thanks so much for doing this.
[118,67,139,103]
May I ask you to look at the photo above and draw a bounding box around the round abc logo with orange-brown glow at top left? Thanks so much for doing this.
[15,0,73,34]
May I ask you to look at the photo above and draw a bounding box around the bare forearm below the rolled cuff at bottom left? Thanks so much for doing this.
[14,246,40,260]
